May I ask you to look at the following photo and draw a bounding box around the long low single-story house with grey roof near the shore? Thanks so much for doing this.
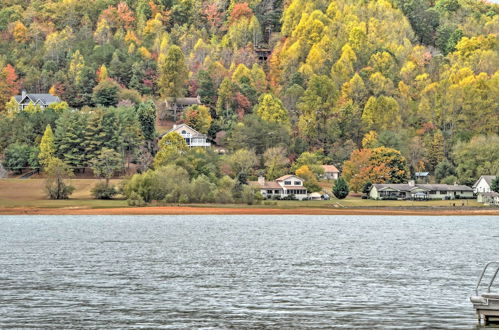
[369,181,474,199]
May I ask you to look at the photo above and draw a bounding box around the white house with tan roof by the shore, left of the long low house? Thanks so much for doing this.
[250,175,308,200]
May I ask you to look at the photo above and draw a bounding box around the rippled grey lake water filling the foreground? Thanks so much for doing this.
[0,216,499,329]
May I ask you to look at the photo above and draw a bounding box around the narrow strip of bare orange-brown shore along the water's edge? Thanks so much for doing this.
[0,206,499,216]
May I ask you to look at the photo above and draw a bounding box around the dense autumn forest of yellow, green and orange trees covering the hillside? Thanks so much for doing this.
[0,0,499,196]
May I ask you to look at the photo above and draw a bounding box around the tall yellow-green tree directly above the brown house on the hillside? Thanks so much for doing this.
[158,45,189,98]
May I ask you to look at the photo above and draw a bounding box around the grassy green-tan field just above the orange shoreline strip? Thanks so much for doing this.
[0,179,483,209]
